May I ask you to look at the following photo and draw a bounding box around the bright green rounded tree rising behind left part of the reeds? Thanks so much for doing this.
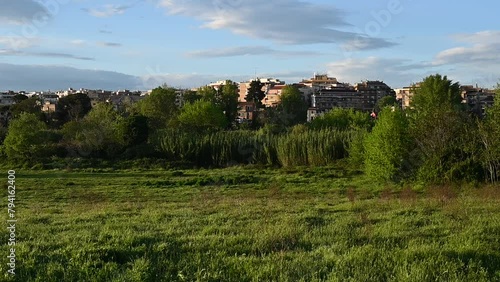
[178,101,227,132]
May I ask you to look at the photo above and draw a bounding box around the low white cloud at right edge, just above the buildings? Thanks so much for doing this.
[328,31,500,87]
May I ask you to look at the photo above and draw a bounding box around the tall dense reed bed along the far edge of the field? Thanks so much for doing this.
[157,129,351,167]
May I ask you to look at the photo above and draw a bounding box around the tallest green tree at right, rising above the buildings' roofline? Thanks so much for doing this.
[408,74,470,183]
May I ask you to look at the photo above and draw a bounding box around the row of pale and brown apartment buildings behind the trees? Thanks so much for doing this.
[0,74,495,121]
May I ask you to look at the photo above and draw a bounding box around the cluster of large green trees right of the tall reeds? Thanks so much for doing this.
[362,75,500,183]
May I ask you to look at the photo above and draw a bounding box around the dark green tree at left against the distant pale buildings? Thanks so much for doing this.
[55,93,92,126]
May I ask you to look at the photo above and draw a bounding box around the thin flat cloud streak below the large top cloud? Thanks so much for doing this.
[186,46,321,58]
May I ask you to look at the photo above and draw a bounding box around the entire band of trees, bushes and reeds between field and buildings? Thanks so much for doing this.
[1,75,500,183]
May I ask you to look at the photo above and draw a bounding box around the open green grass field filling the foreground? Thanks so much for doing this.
[0,167,500,282]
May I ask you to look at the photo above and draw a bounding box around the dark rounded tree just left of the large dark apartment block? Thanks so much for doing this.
[278,85,308,126]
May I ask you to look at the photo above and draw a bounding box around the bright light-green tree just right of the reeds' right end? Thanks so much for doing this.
[364,107,411,182]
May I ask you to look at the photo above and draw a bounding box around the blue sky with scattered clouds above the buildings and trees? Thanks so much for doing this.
[0,0,500,91]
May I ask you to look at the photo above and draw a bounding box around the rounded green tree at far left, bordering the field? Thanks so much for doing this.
[4,113,48,160]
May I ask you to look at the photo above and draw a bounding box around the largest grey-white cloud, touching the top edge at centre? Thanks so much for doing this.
[159,0,395,49]
